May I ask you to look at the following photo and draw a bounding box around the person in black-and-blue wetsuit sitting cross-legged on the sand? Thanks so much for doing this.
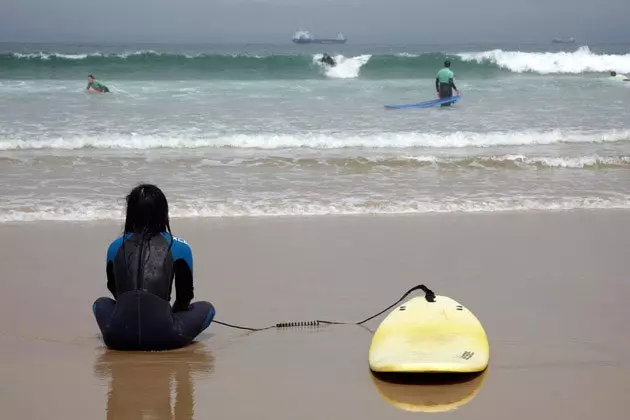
[92,184,215,351]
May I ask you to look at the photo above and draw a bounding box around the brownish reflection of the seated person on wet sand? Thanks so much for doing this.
[94,343,214,420]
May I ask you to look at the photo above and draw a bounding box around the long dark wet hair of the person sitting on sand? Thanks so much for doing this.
[124,184,172,237]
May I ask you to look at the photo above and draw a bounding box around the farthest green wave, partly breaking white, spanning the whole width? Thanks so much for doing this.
[0,46,630,80]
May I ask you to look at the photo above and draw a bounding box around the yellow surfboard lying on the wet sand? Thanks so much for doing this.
[368,295,490,373]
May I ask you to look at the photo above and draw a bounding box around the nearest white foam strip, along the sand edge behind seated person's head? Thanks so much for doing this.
[0,194,630,223]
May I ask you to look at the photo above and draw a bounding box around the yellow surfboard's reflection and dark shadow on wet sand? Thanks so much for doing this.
[372,369,488,413]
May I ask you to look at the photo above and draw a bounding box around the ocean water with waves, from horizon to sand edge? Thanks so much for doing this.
[0,43,630,223]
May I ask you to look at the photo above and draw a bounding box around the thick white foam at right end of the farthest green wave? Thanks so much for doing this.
[457,46,630,74]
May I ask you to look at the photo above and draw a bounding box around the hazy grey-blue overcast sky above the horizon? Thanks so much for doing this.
[0,0,630,44]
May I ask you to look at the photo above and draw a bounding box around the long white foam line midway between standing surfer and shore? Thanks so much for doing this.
[0,130,630,150]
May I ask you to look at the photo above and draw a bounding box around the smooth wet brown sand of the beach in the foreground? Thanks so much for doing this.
[0,211,630,420]
